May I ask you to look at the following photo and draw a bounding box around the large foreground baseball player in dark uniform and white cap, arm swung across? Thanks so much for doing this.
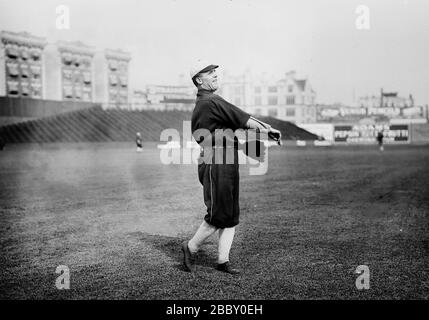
[182,60,281,274]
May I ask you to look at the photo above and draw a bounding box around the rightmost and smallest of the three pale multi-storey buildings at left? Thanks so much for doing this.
[94,49,131,108]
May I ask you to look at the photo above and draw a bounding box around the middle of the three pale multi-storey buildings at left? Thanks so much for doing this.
[44,41,95,102]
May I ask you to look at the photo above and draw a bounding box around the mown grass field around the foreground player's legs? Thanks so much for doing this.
[0,143,429,299]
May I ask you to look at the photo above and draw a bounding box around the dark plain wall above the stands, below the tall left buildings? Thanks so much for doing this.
[0,97,97,117]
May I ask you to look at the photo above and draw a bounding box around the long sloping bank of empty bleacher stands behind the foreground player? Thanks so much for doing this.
[0,106,317,143]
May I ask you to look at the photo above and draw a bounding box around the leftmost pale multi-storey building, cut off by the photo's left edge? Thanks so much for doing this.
[0,31,47,99]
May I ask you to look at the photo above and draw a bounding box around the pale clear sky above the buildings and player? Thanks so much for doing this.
[0,0,429,105]
